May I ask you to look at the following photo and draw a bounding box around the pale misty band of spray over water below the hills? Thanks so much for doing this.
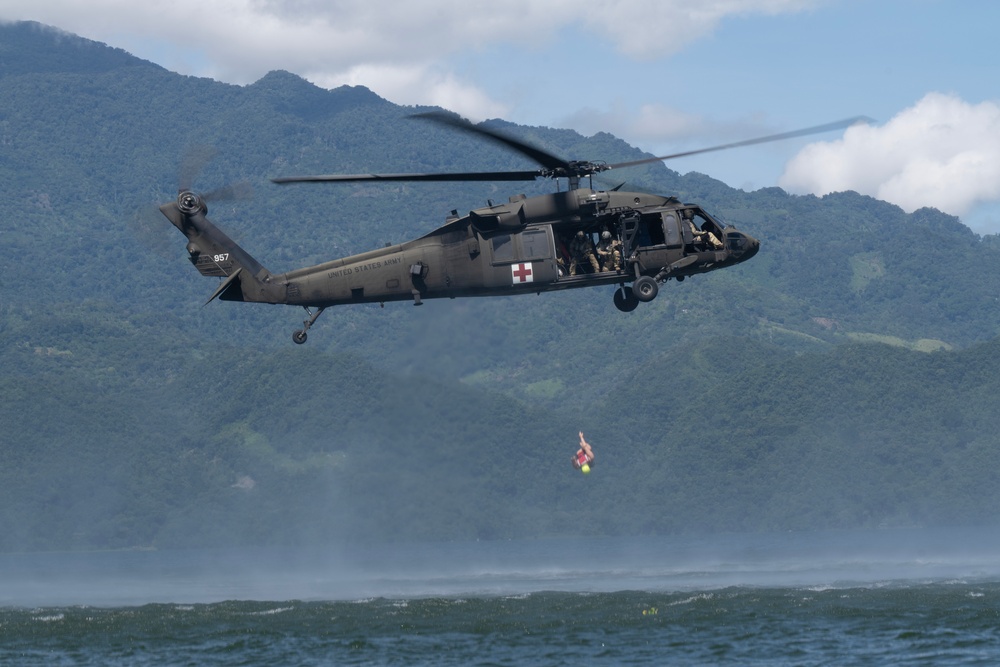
[0,528,1000,606]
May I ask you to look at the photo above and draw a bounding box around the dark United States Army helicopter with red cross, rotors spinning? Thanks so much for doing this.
[160,112,864,344]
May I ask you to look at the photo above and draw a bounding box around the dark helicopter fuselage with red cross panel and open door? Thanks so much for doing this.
[250,189,759,308]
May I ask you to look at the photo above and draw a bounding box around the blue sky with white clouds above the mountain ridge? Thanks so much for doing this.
[0,0,1000,234]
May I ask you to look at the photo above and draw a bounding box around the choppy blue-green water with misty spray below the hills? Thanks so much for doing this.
[0,529,1000,665]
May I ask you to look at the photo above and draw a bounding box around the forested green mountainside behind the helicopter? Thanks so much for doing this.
[0,24,1000,550]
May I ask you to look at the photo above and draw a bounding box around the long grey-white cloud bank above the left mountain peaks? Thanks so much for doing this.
[0,0,820,118]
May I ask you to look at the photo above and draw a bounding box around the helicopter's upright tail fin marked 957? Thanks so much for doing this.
[160,191,273,302]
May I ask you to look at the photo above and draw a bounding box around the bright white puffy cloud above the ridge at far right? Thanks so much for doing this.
[778,93,1000,216]
